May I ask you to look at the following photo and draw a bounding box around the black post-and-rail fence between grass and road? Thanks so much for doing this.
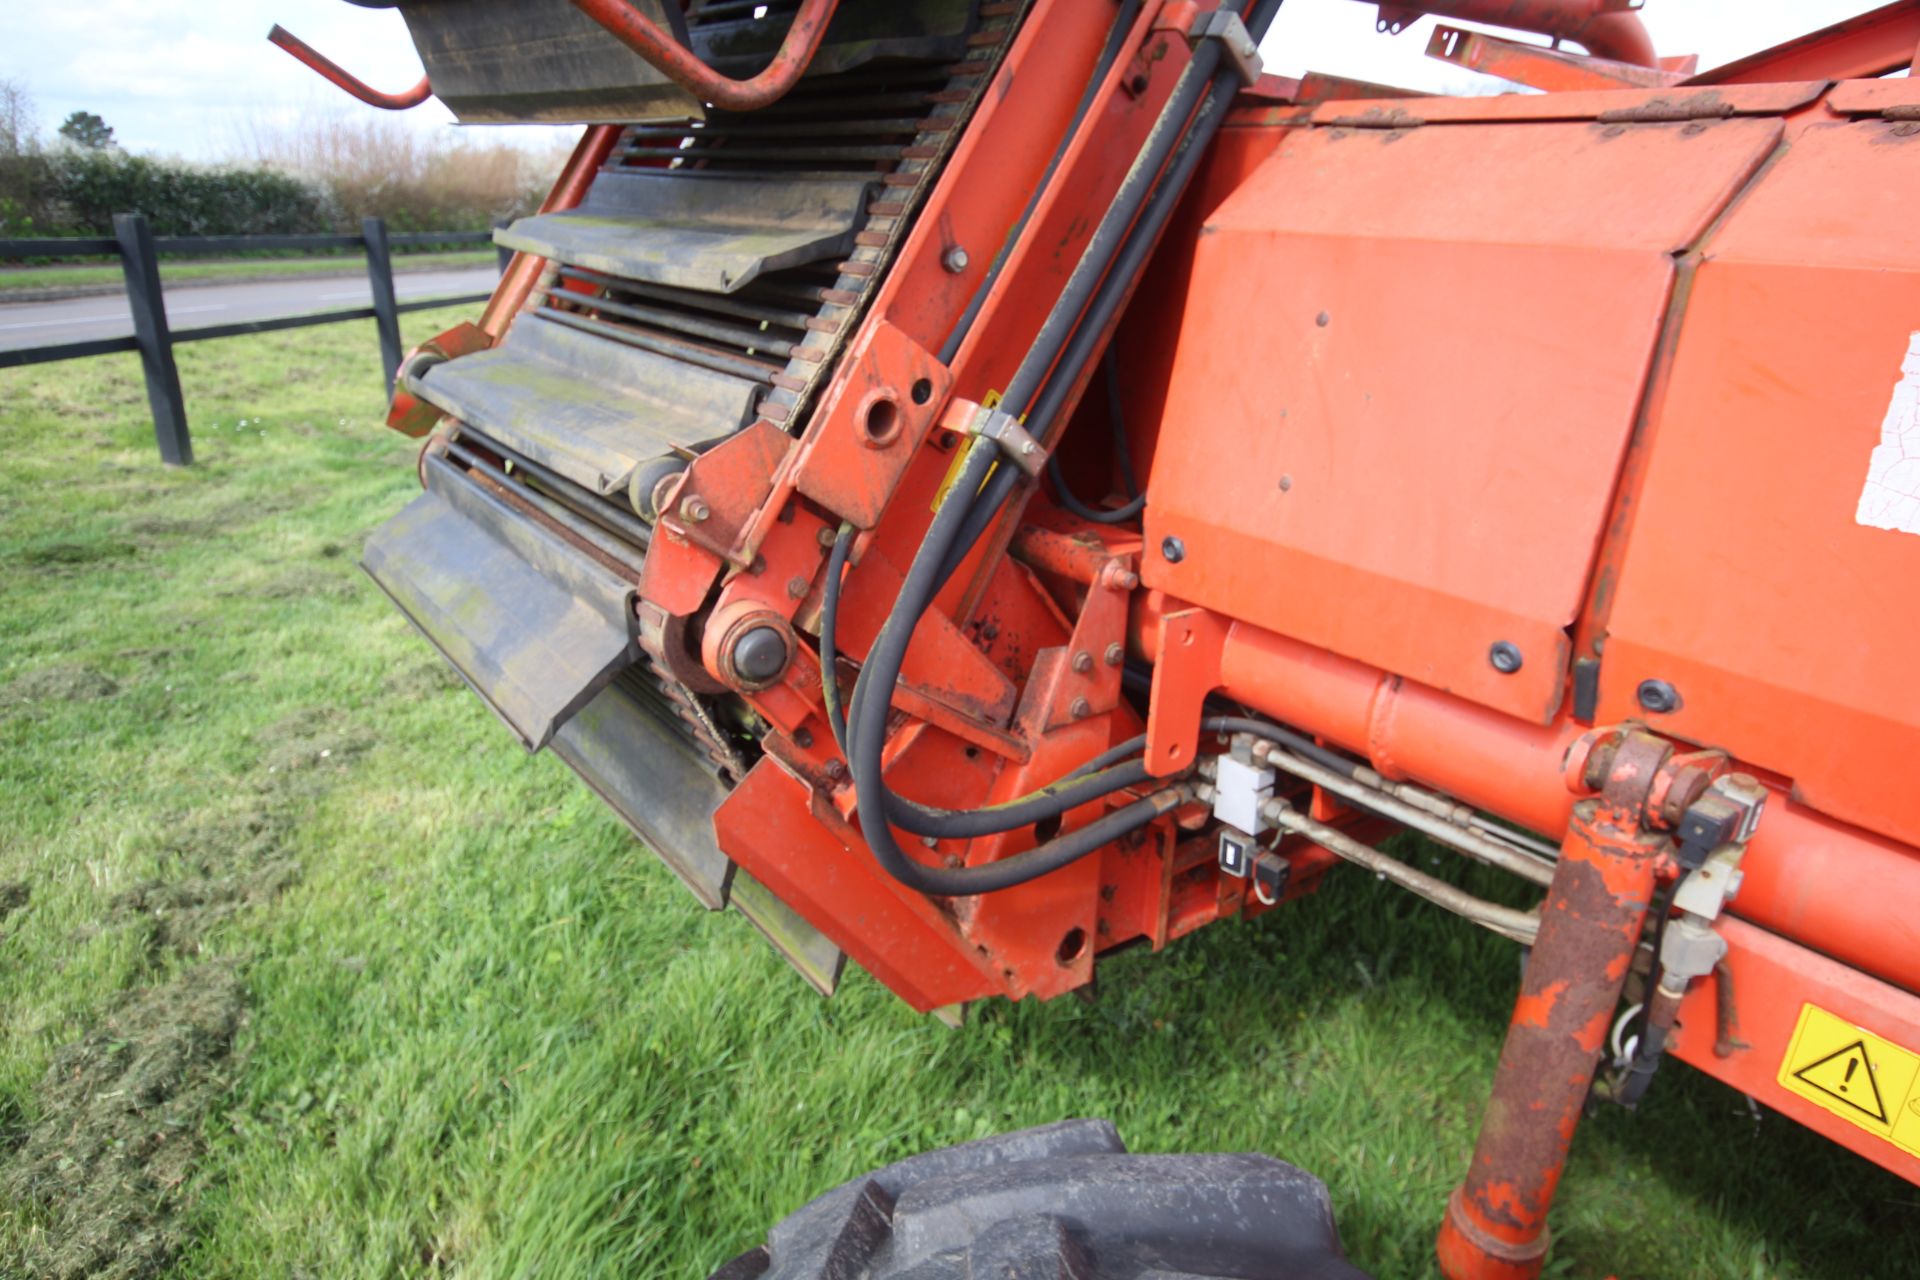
[0,213,511,466]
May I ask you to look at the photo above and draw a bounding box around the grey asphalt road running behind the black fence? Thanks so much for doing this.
[0,267,499,351]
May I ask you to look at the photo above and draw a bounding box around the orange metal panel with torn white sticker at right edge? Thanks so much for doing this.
[1599,121,1920,842]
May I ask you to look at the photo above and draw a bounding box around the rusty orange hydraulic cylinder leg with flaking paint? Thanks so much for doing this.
[1436,729,1674,1280]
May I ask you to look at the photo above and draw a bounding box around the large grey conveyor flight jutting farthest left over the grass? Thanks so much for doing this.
[361,455,639,750]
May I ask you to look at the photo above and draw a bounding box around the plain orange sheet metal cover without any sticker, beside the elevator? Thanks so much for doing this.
[1146,119,1782,722]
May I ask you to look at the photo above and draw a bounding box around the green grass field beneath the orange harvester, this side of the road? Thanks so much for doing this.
[0,313,1920,1280]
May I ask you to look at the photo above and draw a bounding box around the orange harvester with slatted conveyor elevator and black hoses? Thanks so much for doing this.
[311,0,1920,1278]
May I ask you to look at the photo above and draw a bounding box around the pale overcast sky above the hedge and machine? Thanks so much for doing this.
[0,0,1880,161]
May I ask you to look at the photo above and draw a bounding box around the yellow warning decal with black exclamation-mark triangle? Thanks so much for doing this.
[1780,1004,1920,1155]
